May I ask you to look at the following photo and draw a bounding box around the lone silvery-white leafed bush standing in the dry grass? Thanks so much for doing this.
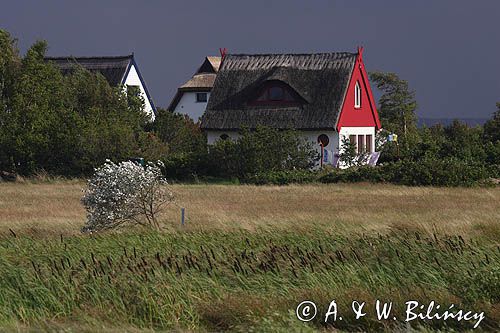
[82,161,173,232]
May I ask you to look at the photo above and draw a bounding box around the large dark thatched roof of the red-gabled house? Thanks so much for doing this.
[201,52,357,130]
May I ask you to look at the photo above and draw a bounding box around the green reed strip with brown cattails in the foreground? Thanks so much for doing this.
[0,227,500,332]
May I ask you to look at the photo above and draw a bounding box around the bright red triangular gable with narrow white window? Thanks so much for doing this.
[337,53,381,131]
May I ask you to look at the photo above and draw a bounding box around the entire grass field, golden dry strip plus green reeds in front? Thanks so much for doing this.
[0,182,500,332]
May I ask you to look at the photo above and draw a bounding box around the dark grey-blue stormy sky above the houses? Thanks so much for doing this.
[0,0,500,118]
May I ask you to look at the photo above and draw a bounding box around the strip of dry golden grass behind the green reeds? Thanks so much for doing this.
[0,182,500,239]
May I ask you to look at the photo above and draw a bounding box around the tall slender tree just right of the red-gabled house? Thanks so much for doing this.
[370,72,417,144]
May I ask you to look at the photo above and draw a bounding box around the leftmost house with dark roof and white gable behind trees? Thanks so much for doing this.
[45,54,156,121]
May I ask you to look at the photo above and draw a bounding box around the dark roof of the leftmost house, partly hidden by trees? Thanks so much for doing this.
[45,54,134,87]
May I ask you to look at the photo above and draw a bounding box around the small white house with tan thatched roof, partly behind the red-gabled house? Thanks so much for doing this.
[168,56,221,121]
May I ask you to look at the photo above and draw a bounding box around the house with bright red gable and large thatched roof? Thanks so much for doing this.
[201,48,381,167]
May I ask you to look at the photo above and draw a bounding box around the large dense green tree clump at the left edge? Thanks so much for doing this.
[0,30,165,176]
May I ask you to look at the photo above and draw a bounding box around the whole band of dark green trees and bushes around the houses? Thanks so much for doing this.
[0,30,500,185]
